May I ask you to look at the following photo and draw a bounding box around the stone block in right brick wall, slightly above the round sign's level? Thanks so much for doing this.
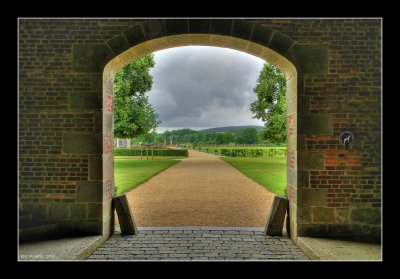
[297,114,332,135]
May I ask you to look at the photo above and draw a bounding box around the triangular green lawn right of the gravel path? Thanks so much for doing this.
[221,157,286,196]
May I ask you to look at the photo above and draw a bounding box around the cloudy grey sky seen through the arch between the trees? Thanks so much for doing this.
[149,46,264,132]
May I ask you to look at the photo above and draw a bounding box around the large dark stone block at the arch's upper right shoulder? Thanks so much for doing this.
[287,45,329,74]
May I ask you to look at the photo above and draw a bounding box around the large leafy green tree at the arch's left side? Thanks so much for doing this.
[114,54,160,138]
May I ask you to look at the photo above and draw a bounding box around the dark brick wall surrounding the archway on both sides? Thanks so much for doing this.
[19,19,381,241]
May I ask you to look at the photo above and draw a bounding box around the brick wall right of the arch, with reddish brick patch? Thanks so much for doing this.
[253,19,381,241]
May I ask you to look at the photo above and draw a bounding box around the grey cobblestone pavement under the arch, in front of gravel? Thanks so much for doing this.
[88,227,308,261]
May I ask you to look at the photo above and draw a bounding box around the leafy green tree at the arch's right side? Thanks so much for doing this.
[250,63,286,143]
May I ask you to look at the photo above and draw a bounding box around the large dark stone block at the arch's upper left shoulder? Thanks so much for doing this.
[72,44,114,73]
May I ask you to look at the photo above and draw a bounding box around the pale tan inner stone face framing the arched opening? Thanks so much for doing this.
[102,20,297,241]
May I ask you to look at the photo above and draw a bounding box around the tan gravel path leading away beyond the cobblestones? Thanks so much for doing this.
[126,150,274,227]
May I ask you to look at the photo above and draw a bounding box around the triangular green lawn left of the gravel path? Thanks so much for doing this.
[114,156,180,195]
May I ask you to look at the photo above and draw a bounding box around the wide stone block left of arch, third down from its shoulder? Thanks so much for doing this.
[63,132,102,154]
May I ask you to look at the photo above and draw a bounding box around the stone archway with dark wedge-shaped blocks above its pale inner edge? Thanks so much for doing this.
[74,20,331,243]
